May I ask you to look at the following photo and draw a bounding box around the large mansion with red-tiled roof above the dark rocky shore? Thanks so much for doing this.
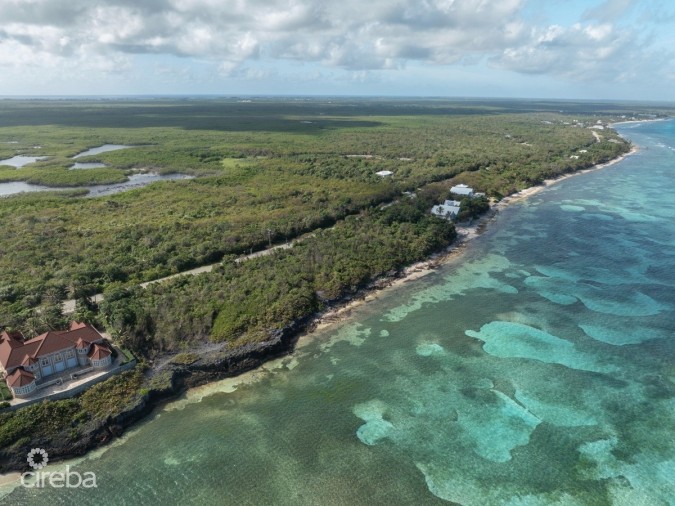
[0,322,112,397]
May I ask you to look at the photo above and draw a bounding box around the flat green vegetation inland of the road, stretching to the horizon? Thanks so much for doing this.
[0,100,635,334]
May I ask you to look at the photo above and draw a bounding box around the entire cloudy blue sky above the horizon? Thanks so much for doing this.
[0,0,675,101]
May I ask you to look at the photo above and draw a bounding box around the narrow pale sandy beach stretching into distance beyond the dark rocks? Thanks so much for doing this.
[306,144,638,334]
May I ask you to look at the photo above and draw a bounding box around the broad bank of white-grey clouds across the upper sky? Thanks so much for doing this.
[0,0,673,93]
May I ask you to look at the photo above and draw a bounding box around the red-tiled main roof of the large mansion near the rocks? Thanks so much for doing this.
[0,322,103,370]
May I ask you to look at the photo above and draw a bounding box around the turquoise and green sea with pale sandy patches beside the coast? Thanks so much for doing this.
[0,121,675,506]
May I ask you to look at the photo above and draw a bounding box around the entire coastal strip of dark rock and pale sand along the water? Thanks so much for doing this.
[0,140,636,478]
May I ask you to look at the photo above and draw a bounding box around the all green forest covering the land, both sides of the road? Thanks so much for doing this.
[0,98,671,349]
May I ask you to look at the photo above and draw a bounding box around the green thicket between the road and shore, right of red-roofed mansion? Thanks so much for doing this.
[101,193,455,354]
